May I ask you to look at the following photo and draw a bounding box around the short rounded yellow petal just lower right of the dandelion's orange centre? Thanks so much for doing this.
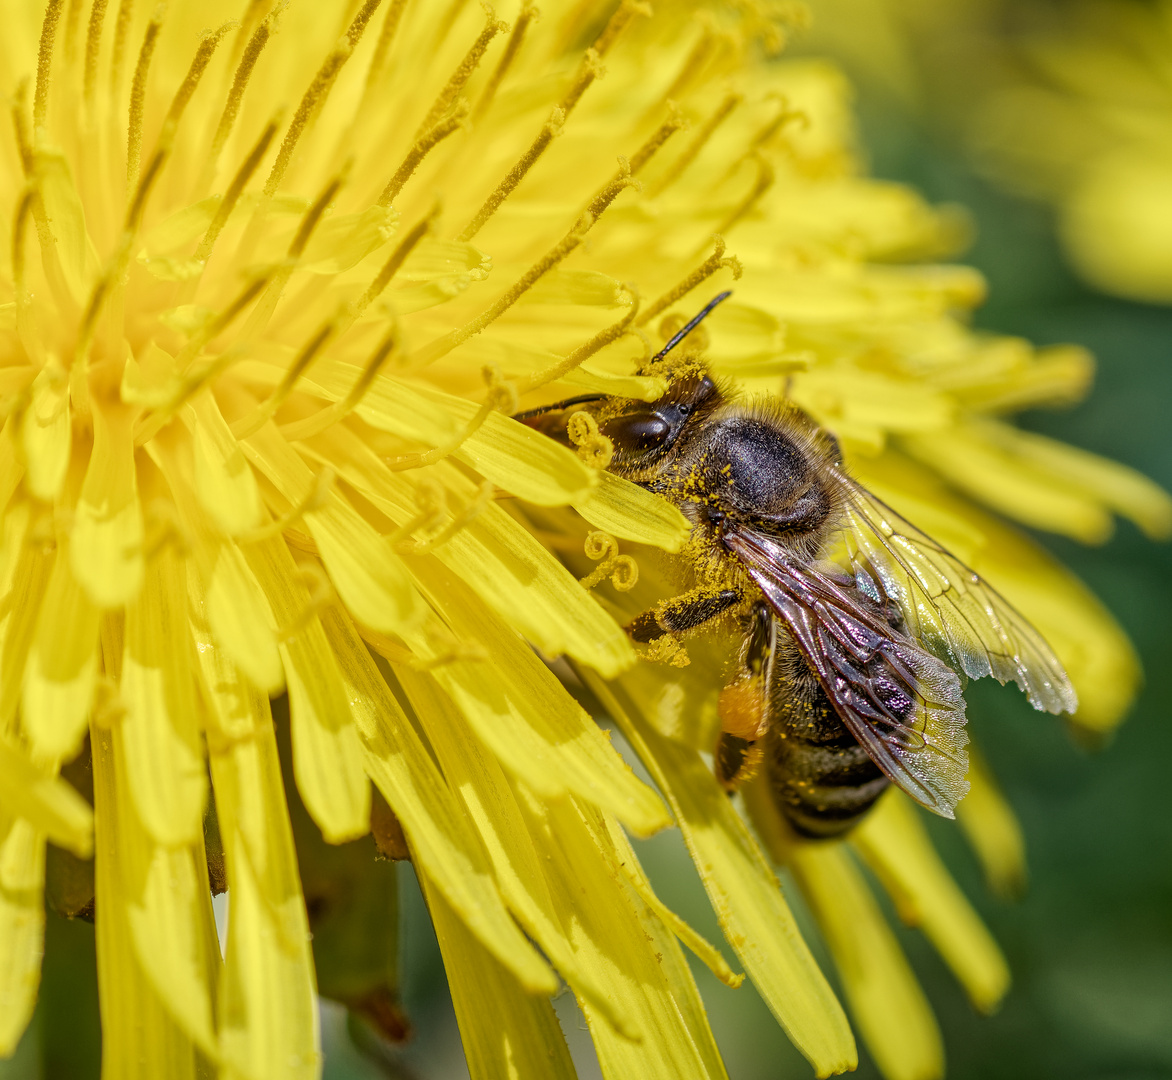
[183,392,260,536]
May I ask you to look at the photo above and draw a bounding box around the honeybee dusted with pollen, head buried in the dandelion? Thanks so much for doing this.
[519,293,1077,838]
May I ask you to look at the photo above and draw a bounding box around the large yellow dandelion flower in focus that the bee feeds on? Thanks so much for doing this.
[0,0,1170,1078]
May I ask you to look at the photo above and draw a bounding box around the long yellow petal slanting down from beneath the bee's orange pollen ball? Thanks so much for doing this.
[582,671,858,1076]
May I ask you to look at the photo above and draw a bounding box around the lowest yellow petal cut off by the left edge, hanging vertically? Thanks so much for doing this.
[0,814,45,1058]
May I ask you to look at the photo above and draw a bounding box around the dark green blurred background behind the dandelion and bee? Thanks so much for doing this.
[0,37,1172,1080]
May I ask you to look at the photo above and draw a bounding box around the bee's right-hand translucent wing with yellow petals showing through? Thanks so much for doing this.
[837,472,1078,712]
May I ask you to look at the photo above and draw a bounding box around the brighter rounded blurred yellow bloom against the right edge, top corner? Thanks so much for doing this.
[972,2,1172,303]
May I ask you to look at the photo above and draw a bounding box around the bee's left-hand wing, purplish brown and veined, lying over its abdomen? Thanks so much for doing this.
[724,529,968,818]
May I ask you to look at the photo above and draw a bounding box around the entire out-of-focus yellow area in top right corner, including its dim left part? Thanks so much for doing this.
[812,0,1172,303]
